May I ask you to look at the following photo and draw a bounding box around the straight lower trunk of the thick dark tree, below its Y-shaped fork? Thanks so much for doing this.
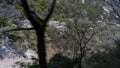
[36,28,47,68]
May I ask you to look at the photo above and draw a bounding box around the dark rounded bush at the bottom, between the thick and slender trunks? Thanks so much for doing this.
[49,54,73,68]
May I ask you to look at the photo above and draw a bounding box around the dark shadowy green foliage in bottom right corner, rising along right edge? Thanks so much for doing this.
[86,39,120,68]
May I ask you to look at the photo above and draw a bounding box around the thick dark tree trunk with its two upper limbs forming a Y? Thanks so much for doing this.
[21,0,56,68]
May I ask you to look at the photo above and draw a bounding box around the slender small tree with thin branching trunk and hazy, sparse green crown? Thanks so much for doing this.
[48,0,105,68]
